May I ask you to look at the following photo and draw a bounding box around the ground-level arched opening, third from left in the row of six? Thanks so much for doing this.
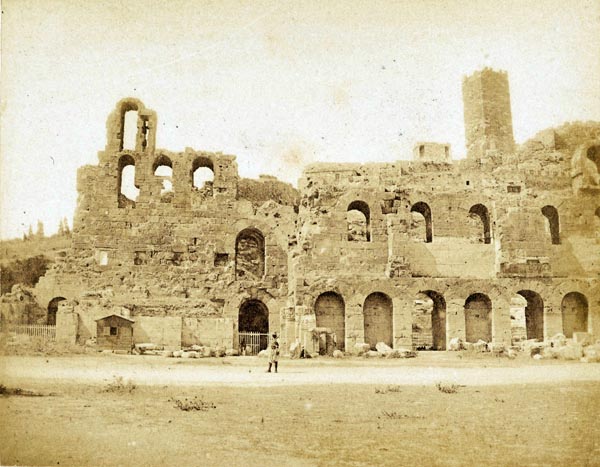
[412,290,446,350]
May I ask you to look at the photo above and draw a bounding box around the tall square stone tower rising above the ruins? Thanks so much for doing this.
[463,68,515,159]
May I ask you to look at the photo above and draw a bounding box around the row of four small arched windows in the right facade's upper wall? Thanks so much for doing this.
[346,200,576,245]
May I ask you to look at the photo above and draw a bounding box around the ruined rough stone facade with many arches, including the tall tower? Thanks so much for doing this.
[35,69,600,352]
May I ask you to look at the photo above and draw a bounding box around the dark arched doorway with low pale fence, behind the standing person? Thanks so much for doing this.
[238,300,269,355]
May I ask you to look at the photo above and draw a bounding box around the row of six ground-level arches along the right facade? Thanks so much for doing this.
[314,290,589,350]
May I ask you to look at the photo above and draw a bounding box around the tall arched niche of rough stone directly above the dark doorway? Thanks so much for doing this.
[235,228,265,281]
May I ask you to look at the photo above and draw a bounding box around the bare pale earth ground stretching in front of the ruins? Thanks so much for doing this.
[0,352,600,466]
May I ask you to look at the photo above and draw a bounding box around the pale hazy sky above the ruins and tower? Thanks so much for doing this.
[0,0,600,238]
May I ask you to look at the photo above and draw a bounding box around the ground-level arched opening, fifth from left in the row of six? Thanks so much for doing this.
[510,290,544,344]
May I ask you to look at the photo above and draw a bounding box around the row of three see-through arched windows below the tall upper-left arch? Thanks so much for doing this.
[117,154,214,207]
